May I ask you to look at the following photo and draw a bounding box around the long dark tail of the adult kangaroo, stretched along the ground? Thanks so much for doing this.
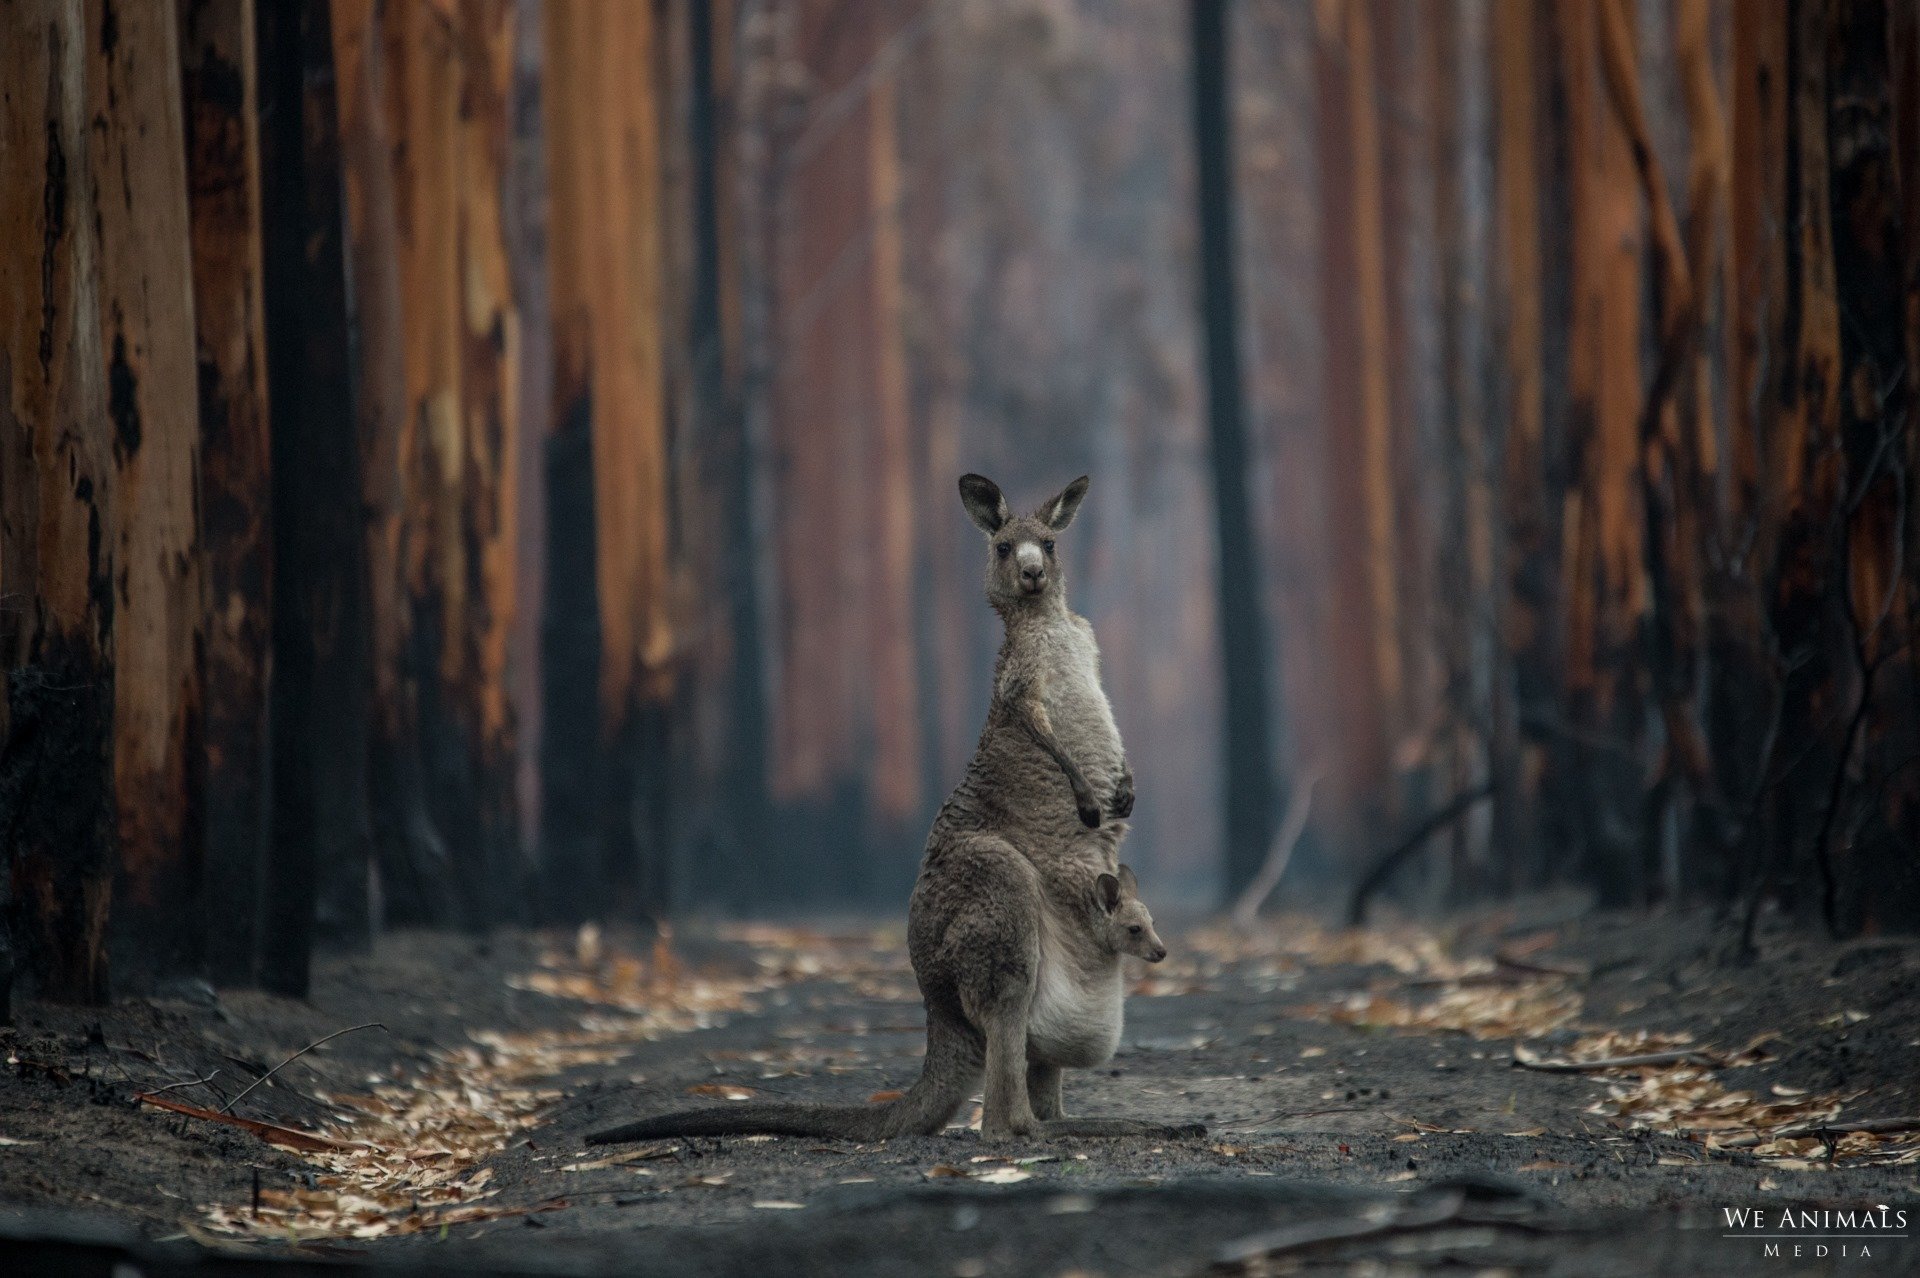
[588,1017,979,1146]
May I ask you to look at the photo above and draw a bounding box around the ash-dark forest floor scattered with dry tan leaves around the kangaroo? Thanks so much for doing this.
[0,894,1920,1278]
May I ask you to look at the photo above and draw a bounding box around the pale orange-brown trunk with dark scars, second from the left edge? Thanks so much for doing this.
[81,0,205,975]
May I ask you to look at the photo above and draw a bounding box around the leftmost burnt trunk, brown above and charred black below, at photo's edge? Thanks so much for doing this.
[0,0,117,1023]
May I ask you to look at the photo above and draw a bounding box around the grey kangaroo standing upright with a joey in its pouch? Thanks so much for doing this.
[588,474,1204,1144]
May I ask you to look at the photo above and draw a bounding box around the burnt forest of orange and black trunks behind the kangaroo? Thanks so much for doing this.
[0,0,1920,1000]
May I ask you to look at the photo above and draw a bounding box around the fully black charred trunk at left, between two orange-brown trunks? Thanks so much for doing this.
[257,0,371,996]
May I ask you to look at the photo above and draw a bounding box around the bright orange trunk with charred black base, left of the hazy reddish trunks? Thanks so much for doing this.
[541,0,674,915]
